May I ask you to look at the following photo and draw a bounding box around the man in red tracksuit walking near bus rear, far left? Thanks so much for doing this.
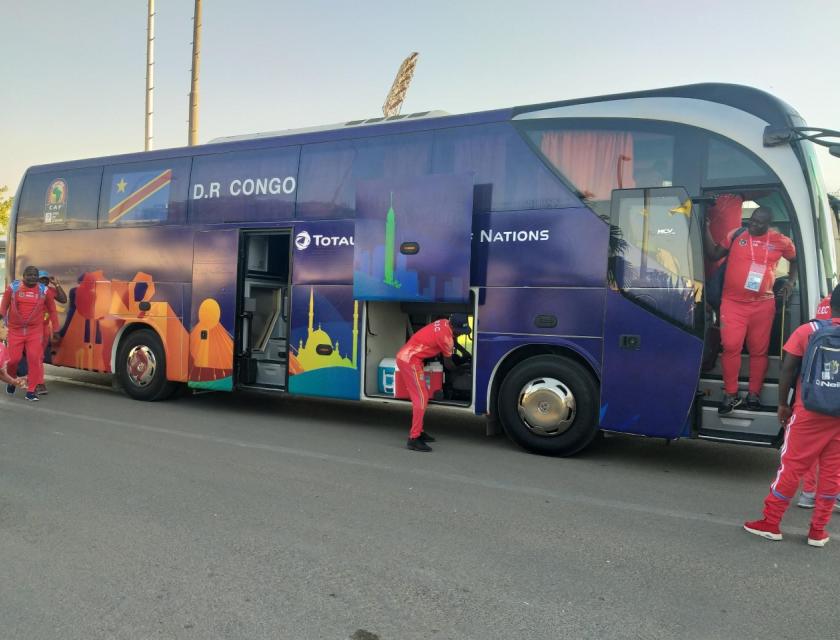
[0,266,59,401]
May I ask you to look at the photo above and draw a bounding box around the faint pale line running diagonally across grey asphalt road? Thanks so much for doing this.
[0,396,788,534]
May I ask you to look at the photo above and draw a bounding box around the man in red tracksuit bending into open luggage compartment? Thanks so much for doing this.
[397,313,470,451]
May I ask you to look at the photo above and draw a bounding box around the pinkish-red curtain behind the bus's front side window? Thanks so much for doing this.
[540,131,636,200]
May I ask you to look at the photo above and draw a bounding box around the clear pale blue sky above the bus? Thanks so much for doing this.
[0,0,840,191]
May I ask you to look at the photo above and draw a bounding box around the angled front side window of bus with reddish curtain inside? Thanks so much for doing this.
[528,122,674,214]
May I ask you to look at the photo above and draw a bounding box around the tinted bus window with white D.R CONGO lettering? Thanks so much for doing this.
[190,147,300,223]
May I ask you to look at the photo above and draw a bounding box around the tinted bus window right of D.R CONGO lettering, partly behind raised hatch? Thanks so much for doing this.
[297,133,434,219]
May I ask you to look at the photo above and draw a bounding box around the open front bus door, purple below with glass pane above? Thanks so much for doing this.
[600,187,705,438]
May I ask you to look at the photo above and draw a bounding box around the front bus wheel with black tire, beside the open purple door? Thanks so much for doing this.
[497,355,599,456]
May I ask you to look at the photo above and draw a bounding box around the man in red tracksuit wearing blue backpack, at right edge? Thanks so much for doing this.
[744,285,840,547]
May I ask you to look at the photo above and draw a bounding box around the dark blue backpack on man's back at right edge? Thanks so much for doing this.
[800,320,840,417]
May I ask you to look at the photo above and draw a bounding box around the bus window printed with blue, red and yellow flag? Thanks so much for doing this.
[99,158,190,227]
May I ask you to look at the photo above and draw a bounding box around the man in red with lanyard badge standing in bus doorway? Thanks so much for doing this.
[704,207,798,415]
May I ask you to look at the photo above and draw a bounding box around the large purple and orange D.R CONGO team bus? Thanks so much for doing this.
[8,84,838,455]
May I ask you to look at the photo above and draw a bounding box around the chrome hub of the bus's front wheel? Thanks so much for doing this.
[516,378,577,438]
